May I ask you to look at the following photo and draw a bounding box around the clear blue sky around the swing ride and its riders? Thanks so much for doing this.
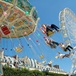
[1,0,76,72]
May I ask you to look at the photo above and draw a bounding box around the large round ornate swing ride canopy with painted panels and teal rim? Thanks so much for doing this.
[0,0,39,38]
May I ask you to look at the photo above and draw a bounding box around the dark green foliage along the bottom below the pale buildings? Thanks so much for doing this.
[3,67,68,76]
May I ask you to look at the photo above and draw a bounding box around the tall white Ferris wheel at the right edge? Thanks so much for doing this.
[59,8,76,76]
